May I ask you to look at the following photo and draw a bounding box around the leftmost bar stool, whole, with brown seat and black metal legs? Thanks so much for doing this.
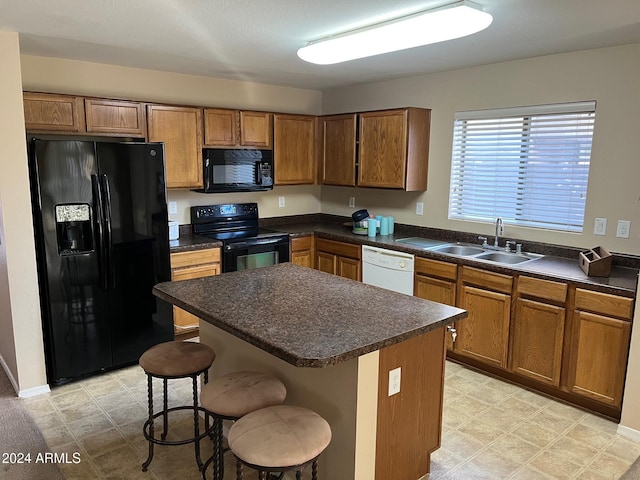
[139,341,216,472]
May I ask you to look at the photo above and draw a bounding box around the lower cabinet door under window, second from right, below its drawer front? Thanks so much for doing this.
[511,298,565,387]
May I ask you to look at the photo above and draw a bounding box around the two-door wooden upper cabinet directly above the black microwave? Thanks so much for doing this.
[204,108,273,149]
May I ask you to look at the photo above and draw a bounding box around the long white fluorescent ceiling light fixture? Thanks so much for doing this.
[298,0,493,65]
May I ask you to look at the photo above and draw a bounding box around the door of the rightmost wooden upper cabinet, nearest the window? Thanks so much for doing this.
[358,110,407,188]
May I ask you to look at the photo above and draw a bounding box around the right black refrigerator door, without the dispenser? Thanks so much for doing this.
[96,143,174,365]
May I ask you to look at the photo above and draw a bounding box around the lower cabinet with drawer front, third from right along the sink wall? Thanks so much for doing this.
[454,267,513,369]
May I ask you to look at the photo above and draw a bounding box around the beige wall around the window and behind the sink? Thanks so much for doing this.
[322,44,640,254]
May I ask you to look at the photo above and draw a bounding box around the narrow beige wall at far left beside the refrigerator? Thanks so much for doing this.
[0,32,46,392]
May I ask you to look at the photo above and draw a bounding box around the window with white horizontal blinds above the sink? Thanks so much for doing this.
[449,102,596,232]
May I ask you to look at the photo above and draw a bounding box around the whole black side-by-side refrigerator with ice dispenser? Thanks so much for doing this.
[28,139,174,385]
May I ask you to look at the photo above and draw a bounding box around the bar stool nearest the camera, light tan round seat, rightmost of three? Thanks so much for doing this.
[229,405,331,480]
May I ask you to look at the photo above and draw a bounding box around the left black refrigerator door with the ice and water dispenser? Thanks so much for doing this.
[29,140,112,384]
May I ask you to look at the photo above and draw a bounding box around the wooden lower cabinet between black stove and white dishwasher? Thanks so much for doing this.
[316,238,362,281]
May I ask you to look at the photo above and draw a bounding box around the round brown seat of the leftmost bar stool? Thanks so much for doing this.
[139,341,216,378]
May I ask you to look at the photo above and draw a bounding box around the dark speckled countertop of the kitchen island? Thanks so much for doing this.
[153,263,467,367]
